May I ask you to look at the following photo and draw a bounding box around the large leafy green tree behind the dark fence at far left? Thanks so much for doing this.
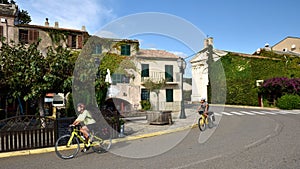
[0,42,78,116]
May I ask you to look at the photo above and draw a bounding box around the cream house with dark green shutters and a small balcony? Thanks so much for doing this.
[104,49,181,114]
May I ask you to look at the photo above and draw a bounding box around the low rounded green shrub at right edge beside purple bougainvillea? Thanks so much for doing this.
[277,94,300,110]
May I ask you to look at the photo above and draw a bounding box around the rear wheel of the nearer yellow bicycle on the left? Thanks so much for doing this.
[92,132,112,153]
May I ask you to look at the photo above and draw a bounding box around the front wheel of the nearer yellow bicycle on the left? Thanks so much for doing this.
[55,135,80,159]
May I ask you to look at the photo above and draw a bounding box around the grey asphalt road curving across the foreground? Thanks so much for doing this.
[0,108,300,169]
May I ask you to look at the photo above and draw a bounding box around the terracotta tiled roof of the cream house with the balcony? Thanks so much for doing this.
[137,49,179,59]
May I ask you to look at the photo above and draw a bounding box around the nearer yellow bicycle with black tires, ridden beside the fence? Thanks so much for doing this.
[55,125,112,159]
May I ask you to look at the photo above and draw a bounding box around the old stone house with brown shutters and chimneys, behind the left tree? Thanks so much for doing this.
[0,4,89,118]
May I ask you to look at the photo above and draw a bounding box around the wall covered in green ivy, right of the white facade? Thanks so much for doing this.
[208,50,300,106]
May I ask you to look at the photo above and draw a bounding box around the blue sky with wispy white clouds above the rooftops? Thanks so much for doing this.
[16,0,300,56]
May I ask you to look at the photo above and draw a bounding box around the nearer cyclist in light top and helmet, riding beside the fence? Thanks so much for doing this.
[72,103,96,152]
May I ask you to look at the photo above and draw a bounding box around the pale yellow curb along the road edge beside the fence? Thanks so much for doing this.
[0,124,197,158]
